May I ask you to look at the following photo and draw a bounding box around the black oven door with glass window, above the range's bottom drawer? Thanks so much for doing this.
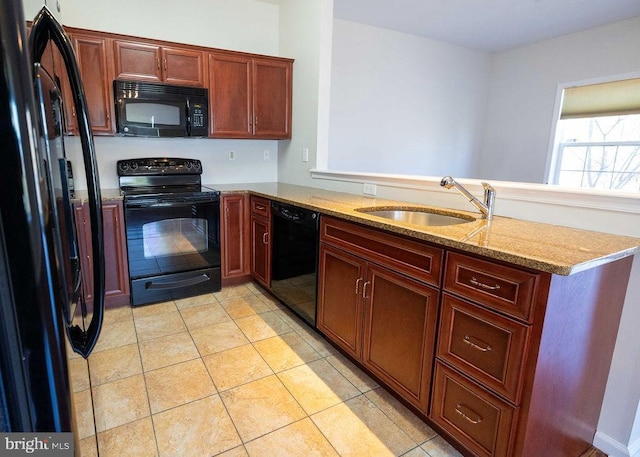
[125,202,220,279]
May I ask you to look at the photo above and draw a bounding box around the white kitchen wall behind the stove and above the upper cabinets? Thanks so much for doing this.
[55,0,280,189]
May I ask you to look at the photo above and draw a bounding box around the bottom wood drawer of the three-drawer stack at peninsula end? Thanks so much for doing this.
[431,361,517,457]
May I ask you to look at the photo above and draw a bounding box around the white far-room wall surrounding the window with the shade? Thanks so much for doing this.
[476,17,640,183]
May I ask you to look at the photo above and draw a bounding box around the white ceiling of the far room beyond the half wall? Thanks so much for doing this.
[262,0,640,52]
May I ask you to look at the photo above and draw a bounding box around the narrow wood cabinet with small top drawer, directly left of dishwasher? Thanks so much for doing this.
[250,195,271,289]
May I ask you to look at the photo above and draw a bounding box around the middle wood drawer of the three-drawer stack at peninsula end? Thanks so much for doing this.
[438,293,529,404]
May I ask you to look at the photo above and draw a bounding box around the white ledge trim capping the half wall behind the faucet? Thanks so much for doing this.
[310,169,640,214]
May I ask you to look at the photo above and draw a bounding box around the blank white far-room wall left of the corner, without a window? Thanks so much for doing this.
[328,19,490,176]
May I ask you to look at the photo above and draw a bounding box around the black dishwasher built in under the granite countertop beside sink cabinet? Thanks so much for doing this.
[271,201,320,327]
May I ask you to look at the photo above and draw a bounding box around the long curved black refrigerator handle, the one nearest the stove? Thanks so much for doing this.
[29,6,105,358]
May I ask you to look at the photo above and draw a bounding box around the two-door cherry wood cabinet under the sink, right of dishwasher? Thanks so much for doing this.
[317,217,442,412]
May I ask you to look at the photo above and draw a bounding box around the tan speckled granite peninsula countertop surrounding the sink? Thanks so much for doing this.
[212,183,640,276]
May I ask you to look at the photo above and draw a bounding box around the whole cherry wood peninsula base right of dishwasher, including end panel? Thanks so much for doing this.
[317,216,633,457]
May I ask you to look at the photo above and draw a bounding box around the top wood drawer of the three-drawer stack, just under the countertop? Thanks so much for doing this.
[444,252,540,322]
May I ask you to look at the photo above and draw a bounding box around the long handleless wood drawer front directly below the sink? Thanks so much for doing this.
[320,216,443,286]
